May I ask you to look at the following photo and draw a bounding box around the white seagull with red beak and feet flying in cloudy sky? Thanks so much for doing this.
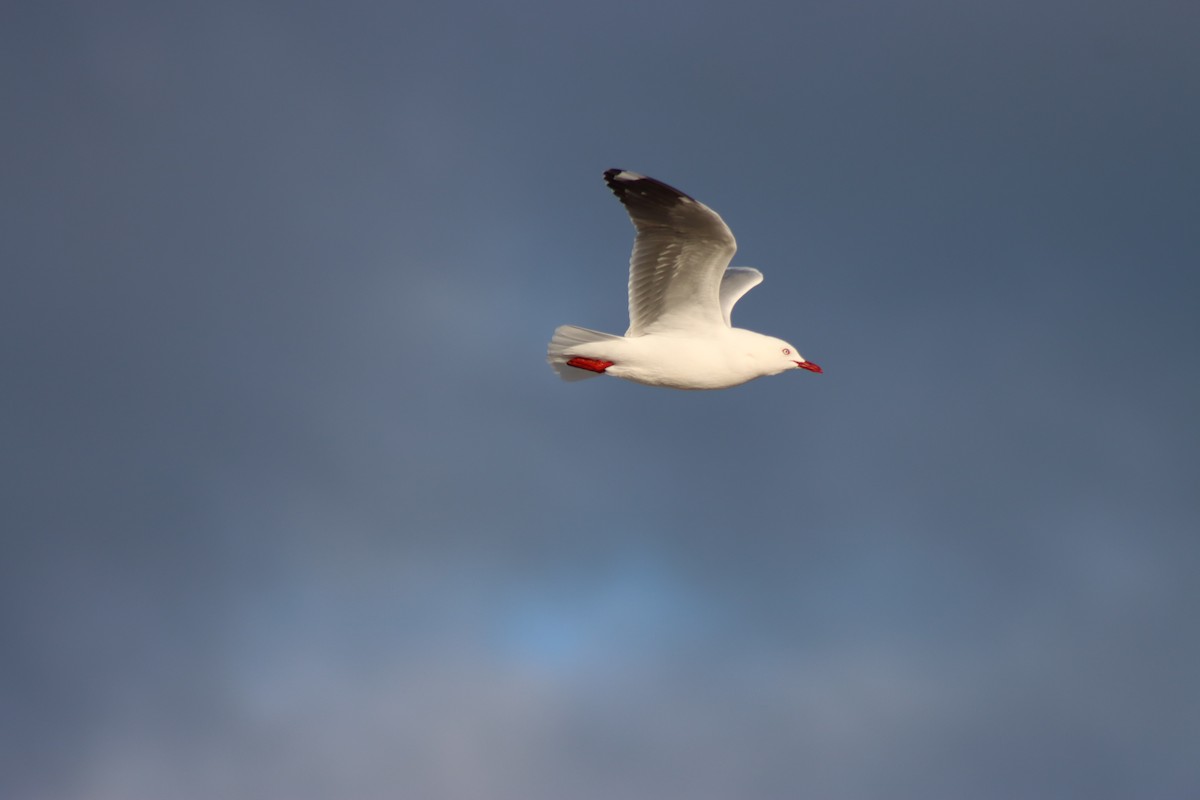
[546,169,821,389]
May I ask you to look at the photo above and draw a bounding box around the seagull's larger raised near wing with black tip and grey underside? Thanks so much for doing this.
[604,169,737,336]
